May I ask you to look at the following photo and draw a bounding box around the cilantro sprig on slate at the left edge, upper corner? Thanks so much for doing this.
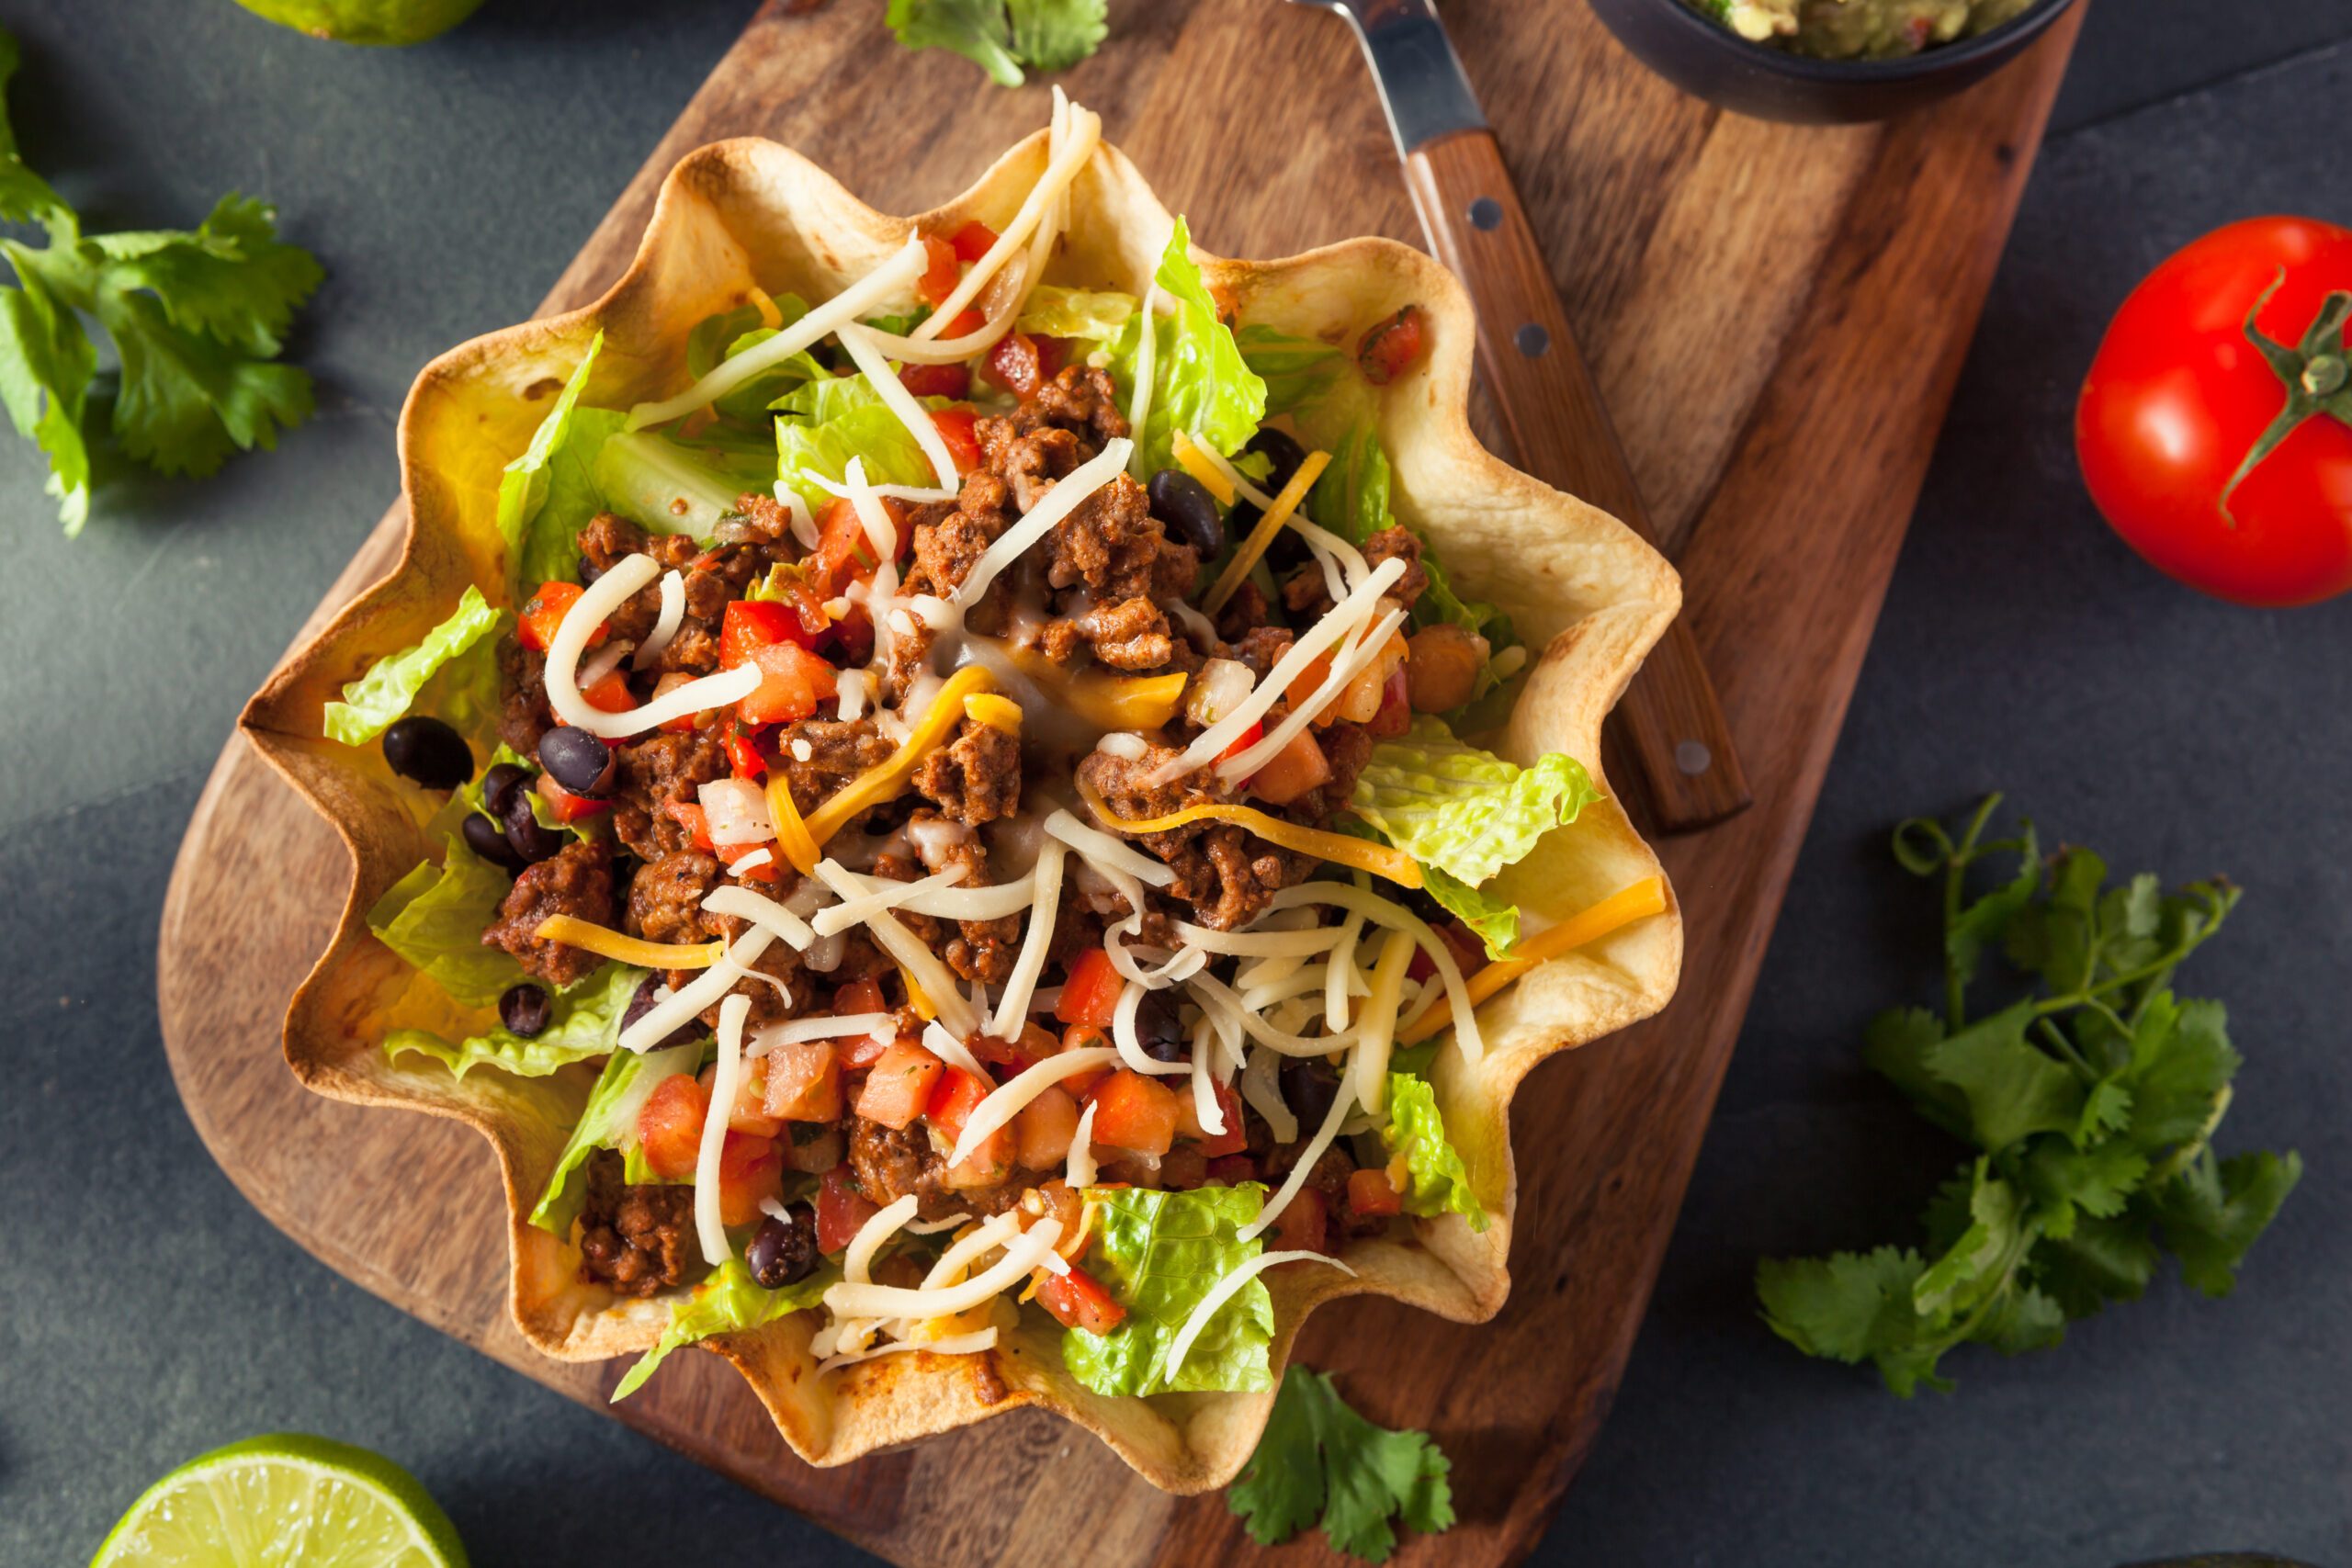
[0,30,322,536]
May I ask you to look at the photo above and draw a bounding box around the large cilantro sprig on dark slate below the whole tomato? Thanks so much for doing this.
[1757,795,2302,1399]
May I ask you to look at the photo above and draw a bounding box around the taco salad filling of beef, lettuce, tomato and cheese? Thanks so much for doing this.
[327,104,1665,1394]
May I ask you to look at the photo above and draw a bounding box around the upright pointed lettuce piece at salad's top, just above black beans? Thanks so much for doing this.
[1110,219,1265,475]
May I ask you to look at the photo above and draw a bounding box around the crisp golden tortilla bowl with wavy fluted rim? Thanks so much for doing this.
[243,131,1681,1493]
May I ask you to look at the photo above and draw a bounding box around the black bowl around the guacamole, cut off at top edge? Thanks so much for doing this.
[1592,0,2075,125]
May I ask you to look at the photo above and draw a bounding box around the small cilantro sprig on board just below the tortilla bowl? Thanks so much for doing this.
[1226,1366,1453,1563]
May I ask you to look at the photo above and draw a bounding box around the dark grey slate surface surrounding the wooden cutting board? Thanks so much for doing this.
[0,0,2352,1568]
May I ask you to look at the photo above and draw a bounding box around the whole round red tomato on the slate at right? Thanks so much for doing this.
[2075,219,2352,606]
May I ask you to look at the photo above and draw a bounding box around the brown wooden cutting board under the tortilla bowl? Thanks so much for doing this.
[158,0,2079,1568]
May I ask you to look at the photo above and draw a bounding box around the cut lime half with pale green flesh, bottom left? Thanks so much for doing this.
[89,1432,466,1568]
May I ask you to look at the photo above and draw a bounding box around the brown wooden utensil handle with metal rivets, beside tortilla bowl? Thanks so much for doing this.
[1404,130,1752,832]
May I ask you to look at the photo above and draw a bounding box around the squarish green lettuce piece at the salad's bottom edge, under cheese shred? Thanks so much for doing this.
[1061,1182,1275,1394]
